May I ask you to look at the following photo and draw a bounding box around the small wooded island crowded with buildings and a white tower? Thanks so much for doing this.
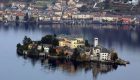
[17,34,130,65]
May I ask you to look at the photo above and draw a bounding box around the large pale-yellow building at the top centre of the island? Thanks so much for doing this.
[59,38,85,49]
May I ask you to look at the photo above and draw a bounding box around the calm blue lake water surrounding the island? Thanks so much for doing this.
[0,24,140,80]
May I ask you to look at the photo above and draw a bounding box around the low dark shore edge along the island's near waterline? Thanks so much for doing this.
[17,51,130,65]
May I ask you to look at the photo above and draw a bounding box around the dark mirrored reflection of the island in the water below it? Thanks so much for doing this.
[19,56,118,80]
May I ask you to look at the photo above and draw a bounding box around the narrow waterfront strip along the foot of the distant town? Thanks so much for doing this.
[0,21,140,26]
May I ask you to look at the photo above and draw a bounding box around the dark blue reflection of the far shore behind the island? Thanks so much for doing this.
[0,23,140,47]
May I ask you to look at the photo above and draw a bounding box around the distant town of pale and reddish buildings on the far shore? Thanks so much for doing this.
[0,0,140,25]
